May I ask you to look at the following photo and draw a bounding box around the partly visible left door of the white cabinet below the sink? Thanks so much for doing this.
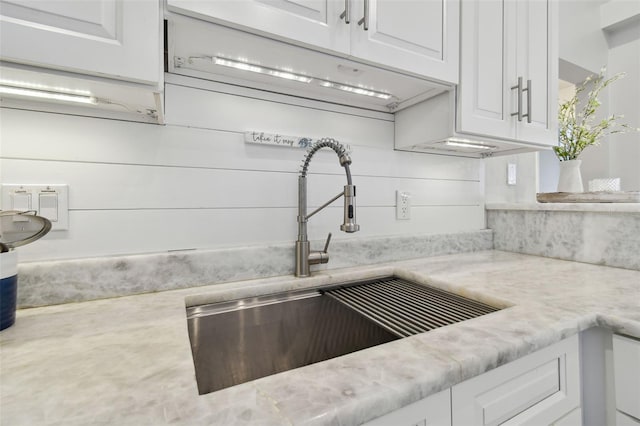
[364,389,451,426]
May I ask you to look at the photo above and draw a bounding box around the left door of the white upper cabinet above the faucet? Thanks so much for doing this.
[167,0,349,54]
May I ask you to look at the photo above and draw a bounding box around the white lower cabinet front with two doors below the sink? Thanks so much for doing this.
[366,335,582,426]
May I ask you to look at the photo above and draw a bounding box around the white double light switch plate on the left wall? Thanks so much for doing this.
[2,183,69,231]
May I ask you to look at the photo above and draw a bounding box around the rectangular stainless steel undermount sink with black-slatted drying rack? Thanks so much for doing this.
[187,277,497,394]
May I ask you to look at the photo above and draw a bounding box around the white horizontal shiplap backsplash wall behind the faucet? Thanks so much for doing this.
[0,78,484,261]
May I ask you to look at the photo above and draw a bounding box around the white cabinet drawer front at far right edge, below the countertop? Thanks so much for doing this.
[613,334,640,419]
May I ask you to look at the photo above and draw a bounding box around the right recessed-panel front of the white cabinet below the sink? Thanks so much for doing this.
[452,336,580,426]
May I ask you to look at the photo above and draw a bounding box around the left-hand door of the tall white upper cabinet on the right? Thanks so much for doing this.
[456,0,515,139]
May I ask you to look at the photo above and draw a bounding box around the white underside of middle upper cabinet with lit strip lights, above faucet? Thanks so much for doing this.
[167,14,450,112]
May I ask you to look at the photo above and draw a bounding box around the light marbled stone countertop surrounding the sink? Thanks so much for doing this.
[0,251,640,426]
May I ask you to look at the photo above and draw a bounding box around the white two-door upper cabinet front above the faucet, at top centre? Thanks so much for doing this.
[167,0,459,84]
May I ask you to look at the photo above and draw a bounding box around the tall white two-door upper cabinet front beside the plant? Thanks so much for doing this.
[457,0,558,145]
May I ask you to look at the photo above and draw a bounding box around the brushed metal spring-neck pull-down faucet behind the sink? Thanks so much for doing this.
[296,138,360,277]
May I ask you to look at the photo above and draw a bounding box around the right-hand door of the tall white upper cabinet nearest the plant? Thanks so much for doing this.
[511,0,558,145]
